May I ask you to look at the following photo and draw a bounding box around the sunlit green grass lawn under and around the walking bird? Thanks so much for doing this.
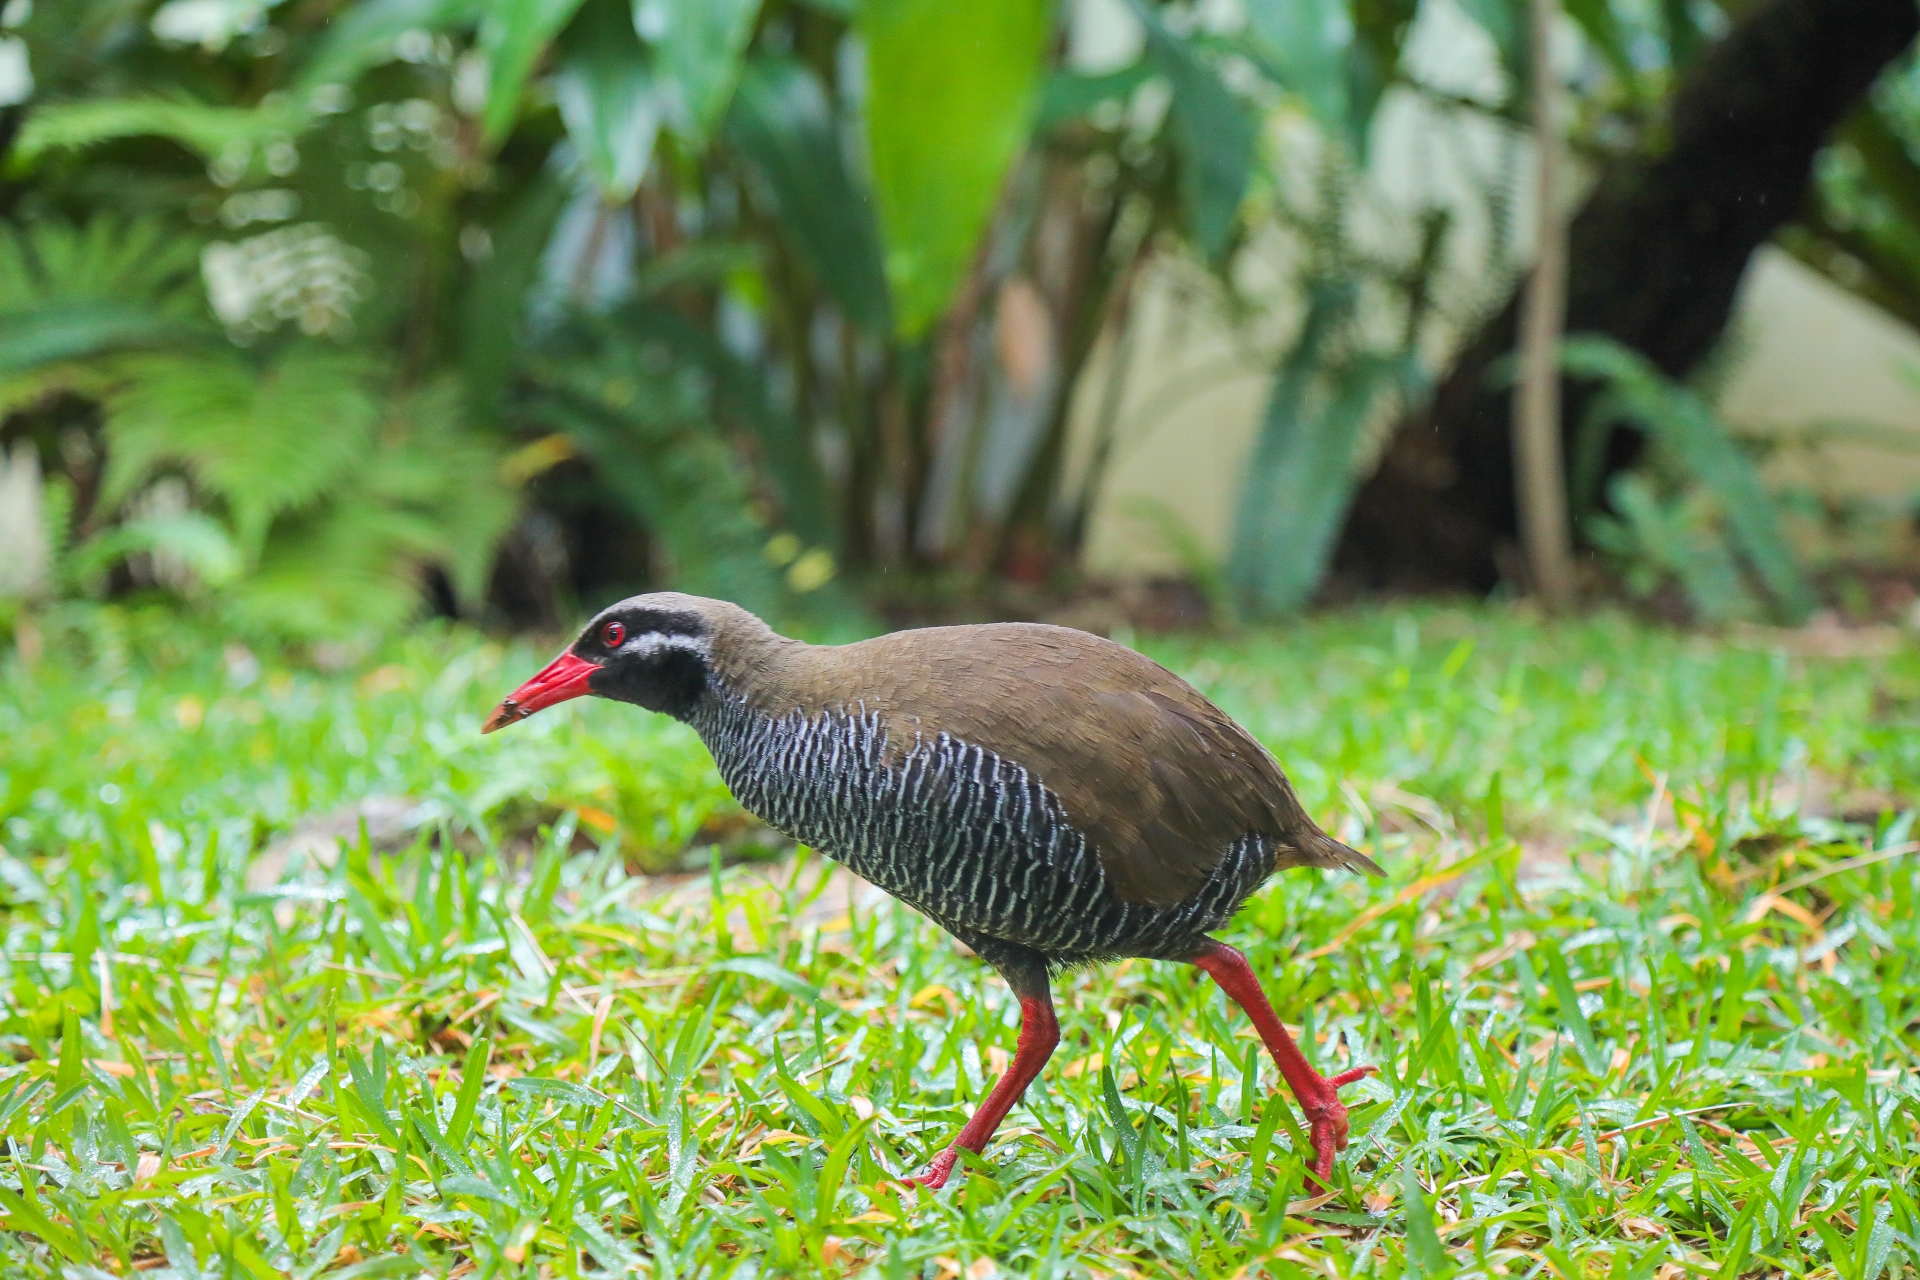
[0,606,1920,1280]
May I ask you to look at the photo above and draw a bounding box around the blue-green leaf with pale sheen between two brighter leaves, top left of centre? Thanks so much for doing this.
[553,0,660,201]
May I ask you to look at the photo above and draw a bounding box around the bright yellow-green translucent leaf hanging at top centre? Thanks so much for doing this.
[856,0,1050,338]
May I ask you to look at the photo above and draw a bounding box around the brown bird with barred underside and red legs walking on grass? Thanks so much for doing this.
[482,591,1384,1190]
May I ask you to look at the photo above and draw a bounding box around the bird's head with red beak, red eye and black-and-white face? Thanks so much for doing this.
[480,593,721,733]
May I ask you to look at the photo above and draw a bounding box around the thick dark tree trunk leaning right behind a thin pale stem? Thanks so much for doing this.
[1334,0,1920,591]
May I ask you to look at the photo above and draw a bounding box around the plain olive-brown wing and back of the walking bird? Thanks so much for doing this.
[808,624,1320,904]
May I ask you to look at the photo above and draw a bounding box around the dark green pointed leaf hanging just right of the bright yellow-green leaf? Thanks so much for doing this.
[1129,0,1256,259]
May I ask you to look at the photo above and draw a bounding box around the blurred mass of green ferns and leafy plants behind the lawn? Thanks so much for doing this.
[0,0,1920,639]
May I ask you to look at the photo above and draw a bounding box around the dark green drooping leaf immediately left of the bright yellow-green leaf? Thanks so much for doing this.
[728,58,891,332]
